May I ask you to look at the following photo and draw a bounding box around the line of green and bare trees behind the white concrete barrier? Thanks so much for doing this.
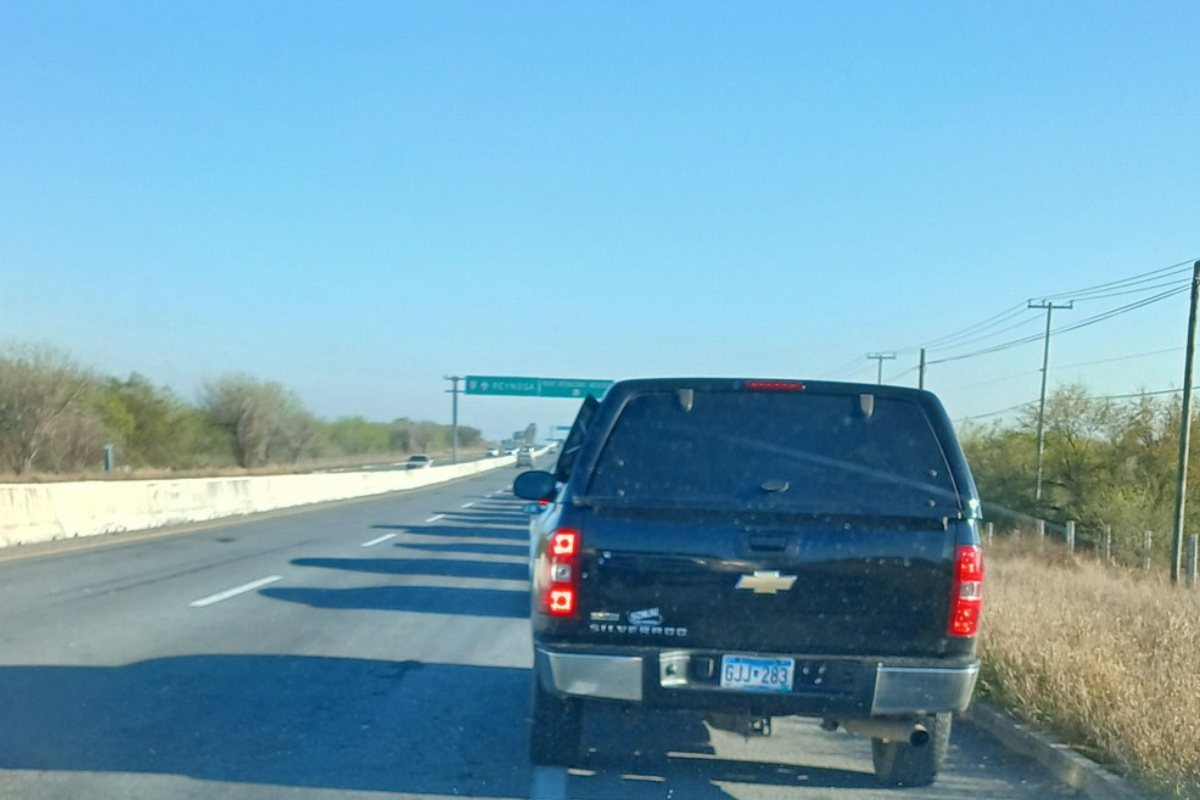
[0,345,485,481]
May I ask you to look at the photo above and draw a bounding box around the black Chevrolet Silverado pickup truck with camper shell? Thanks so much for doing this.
[514,379,983,786]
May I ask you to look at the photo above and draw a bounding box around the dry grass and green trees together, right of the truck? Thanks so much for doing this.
[961,386,1200,800]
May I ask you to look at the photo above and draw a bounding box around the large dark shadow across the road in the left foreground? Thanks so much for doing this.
[0,656,529,798]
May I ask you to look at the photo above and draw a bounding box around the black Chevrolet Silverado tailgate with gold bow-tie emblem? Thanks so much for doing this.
[572,509,962,656]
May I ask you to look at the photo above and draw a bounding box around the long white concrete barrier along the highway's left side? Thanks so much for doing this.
[0,456,515,547]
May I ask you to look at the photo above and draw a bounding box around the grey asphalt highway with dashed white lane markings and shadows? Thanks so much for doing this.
[0,469,1073,800]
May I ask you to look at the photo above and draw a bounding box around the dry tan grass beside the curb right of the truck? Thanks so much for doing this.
[980,542,1200,799]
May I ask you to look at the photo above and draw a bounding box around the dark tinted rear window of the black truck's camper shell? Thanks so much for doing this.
[587,390,960,517]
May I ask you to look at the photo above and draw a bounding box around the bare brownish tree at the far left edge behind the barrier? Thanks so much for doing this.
[0,345,96,475]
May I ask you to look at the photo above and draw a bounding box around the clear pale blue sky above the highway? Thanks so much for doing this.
[0,0,1200,435]
